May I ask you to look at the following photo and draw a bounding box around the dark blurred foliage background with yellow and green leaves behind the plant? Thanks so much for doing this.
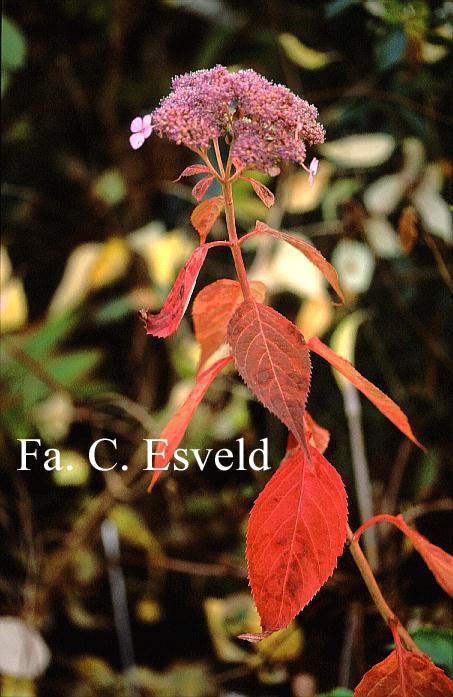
[0,0,453,697]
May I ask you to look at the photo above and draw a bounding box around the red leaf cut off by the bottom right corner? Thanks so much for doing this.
[354,648,453,697]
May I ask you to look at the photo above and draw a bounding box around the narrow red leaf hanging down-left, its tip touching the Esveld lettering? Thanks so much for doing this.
[148,356,232,491]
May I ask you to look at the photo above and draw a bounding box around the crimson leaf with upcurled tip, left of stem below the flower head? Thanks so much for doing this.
[140,245,209,338]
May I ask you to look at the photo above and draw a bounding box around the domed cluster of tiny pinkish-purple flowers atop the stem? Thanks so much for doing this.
[129,66,324,175]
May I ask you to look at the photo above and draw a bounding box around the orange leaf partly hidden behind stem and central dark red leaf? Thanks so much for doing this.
[192,278,266,367]
